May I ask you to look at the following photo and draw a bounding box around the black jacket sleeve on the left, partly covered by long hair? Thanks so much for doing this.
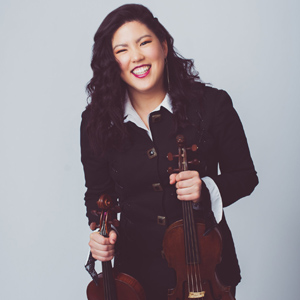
[80,110,114,224]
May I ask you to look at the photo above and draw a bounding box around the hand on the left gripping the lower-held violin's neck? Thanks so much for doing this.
[89,223,117,261]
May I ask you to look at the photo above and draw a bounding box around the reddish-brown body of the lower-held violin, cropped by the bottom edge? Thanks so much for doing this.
[86,269,146,300]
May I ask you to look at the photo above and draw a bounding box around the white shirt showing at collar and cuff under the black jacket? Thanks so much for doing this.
[124,94,223,223]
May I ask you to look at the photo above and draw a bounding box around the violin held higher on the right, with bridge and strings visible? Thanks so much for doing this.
[163,135,235,300]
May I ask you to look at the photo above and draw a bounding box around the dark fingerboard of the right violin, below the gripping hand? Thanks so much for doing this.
[182,201,200,265]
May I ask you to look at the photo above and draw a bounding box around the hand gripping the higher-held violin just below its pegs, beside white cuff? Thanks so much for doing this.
[170,171,202,203]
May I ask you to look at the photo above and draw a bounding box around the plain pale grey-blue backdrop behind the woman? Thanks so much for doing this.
[0,0,300,300]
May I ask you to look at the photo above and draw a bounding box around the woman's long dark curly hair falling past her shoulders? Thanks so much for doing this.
[86,4,200,150]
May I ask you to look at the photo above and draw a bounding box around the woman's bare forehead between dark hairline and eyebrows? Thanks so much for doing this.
[112,21,156,46]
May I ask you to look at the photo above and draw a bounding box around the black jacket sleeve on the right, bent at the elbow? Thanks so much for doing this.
[207,91,258,207]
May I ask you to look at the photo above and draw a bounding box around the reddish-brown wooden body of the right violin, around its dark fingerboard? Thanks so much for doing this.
[163,220,234,300]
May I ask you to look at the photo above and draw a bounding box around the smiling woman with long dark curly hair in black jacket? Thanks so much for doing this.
[81,4,258,300]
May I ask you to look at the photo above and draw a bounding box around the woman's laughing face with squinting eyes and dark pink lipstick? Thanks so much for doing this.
[112,21,168,97]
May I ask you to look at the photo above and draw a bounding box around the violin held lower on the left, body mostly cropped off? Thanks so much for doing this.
[86,195,146,300]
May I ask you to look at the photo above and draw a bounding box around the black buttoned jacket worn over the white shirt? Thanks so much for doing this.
[81,83,258,294]
